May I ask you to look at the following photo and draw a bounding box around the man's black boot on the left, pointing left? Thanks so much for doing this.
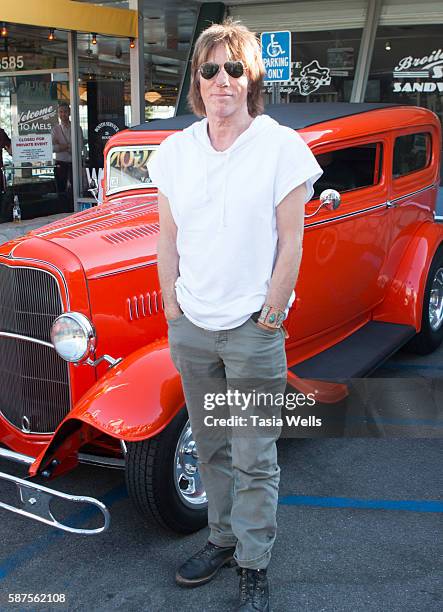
[175,542,237,587]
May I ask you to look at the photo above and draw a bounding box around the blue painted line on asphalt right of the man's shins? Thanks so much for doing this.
[278,495,443,512]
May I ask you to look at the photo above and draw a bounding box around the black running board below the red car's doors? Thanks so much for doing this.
[289,321,417,383]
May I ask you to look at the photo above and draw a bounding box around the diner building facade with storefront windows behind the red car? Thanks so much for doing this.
[0,0,443,220]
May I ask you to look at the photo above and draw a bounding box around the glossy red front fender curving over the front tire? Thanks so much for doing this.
[29,338,185,476]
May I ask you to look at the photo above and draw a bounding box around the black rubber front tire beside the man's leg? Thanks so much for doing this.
[126,408,208,533]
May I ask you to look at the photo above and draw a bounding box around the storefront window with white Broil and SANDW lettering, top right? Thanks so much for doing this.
[365,24,443,146]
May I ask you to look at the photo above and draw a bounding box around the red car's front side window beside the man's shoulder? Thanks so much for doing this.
[313,142,383,198]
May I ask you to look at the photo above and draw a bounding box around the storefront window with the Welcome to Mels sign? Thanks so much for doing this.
[0,25,73,221]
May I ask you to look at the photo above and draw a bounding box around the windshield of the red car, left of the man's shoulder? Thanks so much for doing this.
[106,145,158,195]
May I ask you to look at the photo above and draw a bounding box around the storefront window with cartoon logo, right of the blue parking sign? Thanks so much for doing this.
[265,28,362,102]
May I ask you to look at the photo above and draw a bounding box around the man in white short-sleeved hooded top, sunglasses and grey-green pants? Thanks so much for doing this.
[151,20,322,612]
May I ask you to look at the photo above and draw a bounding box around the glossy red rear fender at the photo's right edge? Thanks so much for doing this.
[372,222,443,332]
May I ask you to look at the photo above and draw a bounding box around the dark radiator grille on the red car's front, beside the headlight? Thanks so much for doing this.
[0,264,70,433]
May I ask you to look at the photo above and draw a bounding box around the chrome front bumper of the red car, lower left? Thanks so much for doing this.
[0,472,111,535]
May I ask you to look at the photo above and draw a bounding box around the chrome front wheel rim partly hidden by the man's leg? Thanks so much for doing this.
[174,420,207,510]
